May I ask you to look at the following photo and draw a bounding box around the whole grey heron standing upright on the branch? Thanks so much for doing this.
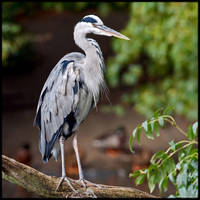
[34,15,129,191]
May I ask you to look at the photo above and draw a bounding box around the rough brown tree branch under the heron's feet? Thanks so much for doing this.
[2,155,155,198]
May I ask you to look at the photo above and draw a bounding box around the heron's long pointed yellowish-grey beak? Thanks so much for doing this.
[95,25,130,40]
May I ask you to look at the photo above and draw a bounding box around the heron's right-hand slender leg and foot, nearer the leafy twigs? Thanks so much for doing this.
[73,135,101,188]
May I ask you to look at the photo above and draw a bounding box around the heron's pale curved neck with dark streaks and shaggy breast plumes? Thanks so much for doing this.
[74,25,106,104]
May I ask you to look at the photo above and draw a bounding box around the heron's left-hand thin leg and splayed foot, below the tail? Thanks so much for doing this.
[56,136,77,192]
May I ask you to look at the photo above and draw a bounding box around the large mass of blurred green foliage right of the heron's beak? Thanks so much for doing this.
[107,2,198,120]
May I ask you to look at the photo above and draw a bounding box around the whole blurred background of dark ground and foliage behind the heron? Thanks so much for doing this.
[2,2,198,197]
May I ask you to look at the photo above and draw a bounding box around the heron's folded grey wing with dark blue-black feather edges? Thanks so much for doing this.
[35,60,79,160]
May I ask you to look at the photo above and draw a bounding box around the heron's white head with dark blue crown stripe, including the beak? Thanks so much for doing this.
[75,15,129,40]
